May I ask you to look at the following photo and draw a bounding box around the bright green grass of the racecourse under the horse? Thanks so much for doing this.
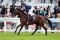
[0,32,60,40]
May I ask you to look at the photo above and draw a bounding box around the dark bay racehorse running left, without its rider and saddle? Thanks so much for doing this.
[11,8,52,35]
